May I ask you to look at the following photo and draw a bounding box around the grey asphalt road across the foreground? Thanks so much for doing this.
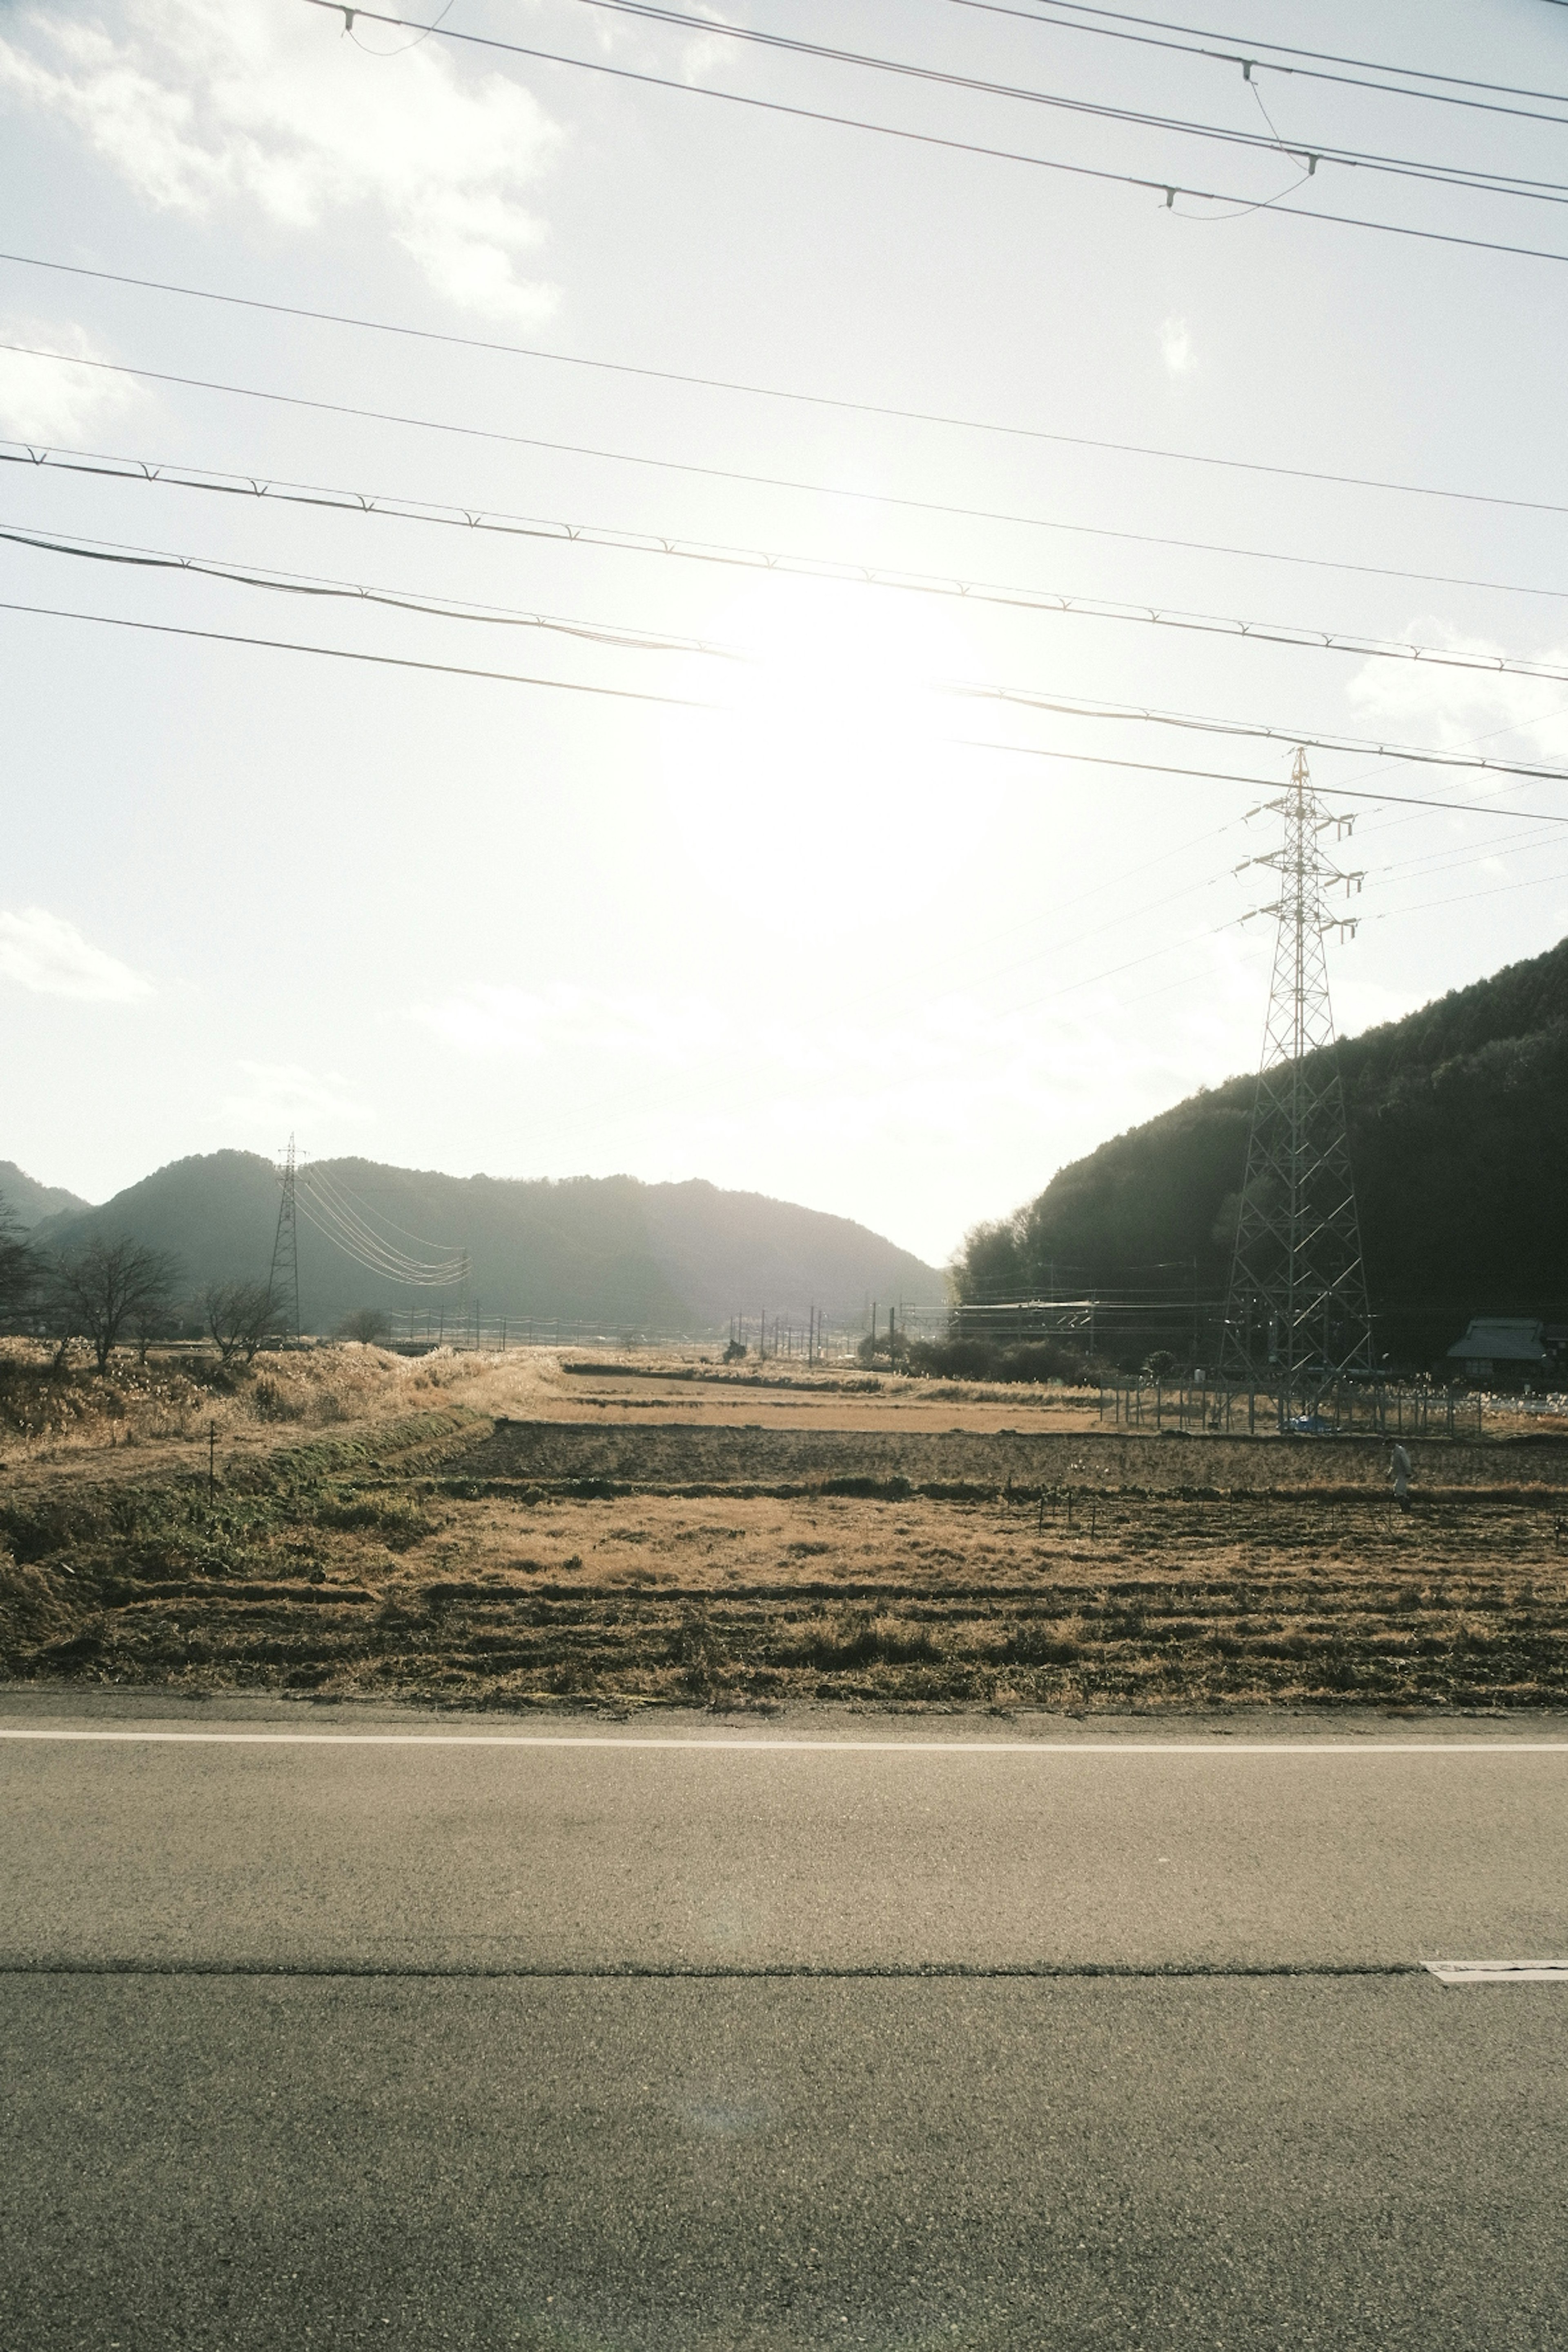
[0,1696,1568,2352]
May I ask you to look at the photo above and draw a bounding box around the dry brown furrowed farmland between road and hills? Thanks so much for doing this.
[0,1343,1568,1712]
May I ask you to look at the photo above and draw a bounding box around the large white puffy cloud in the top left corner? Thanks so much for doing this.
[0,0,562,320]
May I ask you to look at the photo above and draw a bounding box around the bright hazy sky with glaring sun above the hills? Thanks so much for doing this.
[0,0,1568,1263]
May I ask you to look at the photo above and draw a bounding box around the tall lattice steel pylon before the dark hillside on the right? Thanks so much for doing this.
[1223,750,1373,1392]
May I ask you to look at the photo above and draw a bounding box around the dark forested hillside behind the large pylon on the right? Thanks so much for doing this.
[959,917,1568,1364]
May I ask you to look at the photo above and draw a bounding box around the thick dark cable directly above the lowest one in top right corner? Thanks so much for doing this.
[564,0,1568,205]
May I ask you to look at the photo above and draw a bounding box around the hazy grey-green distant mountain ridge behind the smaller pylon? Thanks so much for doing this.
[38,1152,945,1334]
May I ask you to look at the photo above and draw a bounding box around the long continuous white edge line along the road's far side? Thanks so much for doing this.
[0,1724,1568,1757]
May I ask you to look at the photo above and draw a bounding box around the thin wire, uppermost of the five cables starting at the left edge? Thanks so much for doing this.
[0,252,1568,515]
